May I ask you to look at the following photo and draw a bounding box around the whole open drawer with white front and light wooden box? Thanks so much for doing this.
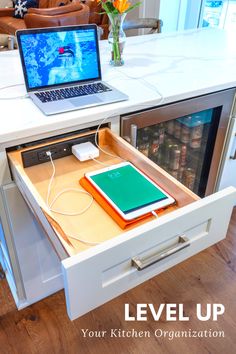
[8,128,236,320]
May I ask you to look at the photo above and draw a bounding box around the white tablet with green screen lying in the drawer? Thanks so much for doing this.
[85,162,175,220]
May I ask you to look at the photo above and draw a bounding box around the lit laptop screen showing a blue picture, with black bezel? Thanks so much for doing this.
[17,25,101,91]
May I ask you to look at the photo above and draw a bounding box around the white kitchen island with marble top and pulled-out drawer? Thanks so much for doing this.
[0,29,236,319]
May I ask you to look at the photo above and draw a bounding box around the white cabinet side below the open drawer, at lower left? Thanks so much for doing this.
[2,183,63,308]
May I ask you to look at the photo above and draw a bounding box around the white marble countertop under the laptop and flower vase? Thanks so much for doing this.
[0,28,236,144]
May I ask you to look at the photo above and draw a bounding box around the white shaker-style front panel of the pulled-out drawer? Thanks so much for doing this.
[62,187,236,320]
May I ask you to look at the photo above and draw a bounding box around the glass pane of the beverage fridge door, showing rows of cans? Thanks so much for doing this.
[128,108,220,197]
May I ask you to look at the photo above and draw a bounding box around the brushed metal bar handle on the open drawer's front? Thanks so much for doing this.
[132,236,190,270]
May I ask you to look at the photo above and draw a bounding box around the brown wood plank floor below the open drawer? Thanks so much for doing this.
[0,208,236,354]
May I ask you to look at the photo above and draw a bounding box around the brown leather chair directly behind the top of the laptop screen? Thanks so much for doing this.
[24,1,89,28]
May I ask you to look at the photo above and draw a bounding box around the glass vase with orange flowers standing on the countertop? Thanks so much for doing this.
[97,0,141,66]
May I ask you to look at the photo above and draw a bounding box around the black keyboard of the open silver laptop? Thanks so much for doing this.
[35,82,112,103]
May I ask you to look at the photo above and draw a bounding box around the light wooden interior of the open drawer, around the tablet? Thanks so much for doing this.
[8,128,199,256]
